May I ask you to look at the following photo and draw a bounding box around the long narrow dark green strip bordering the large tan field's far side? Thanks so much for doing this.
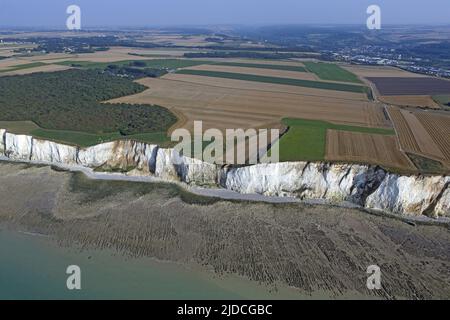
[177,70,370,94]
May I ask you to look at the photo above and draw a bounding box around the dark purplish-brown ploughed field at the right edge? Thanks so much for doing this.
[367,77,450,96]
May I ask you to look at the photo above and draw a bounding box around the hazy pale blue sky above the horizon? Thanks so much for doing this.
[0,0,450,28]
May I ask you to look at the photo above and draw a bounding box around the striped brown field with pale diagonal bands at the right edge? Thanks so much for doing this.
[388,107,450,165]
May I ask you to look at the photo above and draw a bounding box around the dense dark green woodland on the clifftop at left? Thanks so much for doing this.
[0,70,176,135]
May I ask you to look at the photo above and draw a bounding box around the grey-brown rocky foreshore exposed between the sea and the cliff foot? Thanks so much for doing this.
[0,163,450,299]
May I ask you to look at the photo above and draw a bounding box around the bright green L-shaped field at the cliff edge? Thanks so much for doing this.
[280,118,395,161]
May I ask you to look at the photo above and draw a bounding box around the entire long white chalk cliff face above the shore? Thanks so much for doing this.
[0,129,450,217]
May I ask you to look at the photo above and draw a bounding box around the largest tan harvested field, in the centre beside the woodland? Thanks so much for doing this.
[107,74,387,129]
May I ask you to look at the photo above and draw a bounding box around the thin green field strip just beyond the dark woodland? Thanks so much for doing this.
[58,59,210,69]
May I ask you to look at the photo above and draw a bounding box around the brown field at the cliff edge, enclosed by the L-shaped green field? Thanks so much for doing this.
[325,130,415,170]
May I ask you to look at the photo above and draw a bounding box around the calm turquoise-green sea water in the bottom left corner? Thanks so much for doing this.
[0,229,299,299]
